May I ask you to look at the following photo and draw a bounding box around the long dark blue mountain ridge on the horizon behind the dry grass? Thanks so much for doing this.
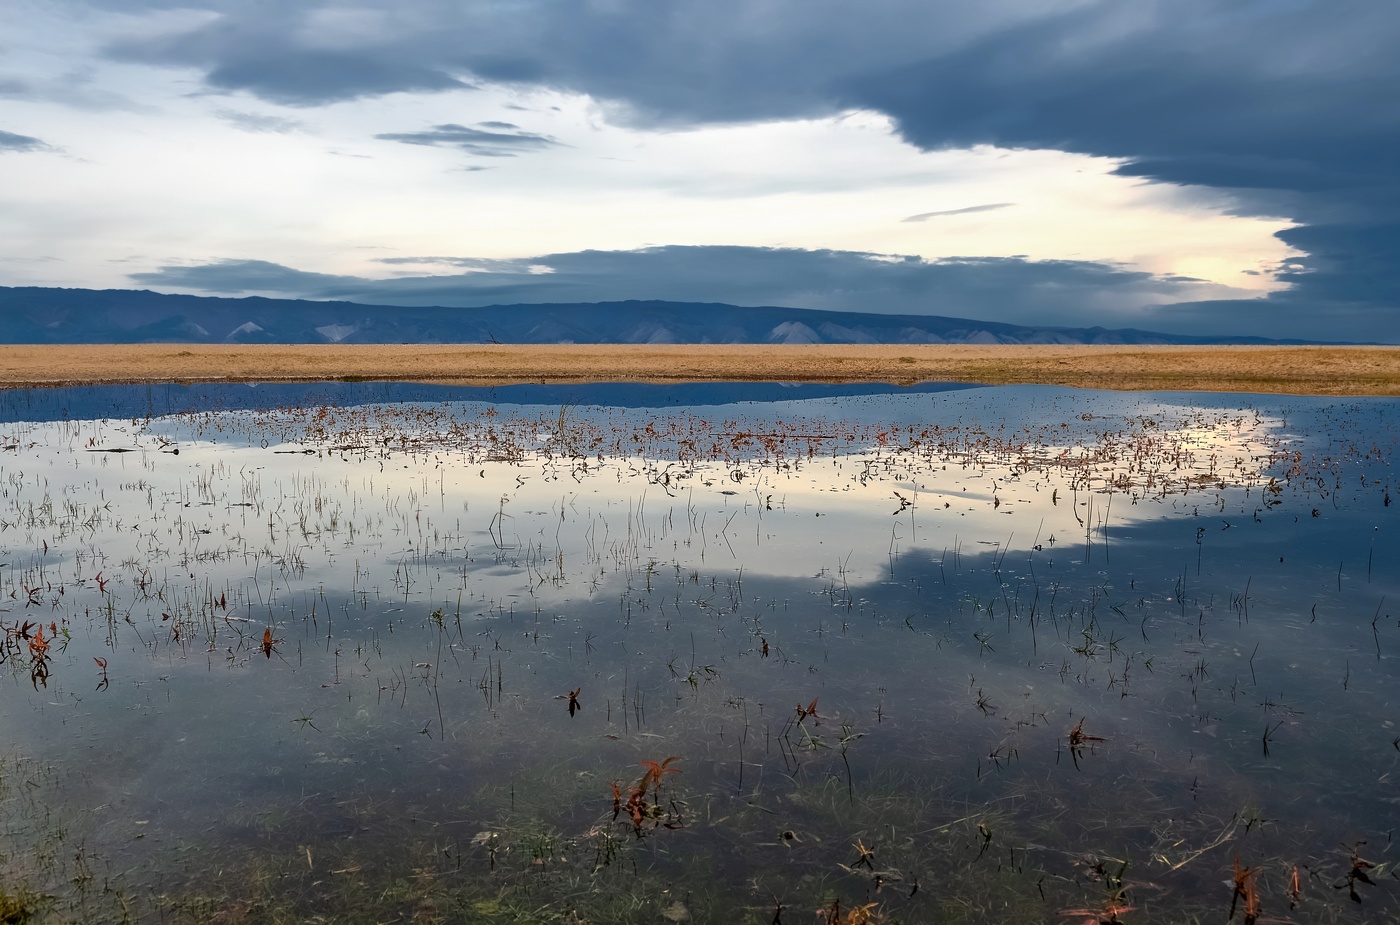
[0,287,1303,344]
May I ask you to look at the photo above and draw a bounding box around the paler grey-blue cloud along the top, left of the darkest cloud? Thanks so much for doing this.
[95,0,1030,113]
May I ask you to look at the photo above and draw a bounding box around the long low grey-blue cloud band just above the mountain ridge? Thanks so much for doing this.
[132,246,1220,327]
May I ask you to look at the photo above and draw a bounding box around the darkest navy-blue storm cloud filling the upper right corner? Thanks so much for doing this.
[850,1,1400,341]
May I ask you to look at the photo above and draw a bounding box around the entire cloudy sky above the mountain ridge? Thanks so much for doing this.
[0,0,1400,343]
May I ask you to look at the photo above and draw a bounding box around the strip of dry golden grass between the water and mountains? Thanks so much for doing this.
[0,344,1400,395]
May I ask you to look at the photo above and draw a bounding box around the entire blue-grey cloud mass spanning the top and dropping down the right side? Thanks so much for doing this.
[90,0,1400,338]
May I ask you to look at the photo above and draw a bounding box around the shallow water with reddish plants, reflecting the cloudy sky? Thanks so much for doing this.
[0,385,1400,922]
